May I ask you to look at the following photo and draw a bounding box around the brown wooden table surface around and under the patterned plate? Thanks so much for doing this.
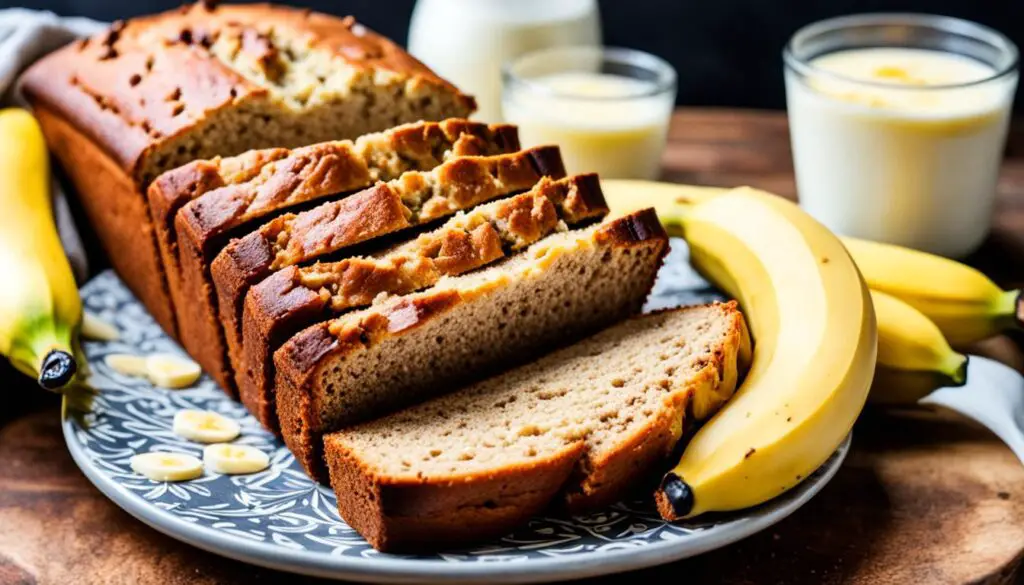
[0,110,1024,584]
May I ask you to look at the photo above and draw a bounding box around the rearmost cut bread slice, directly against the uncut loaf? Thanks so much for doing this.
[146,119,519,340]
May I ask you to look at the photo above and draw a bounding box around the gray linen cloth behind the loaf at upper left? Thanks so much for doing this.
[0,8,106,282]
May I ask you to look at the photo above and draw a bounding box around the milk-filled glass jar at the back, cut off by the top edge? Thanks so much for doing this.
[409,0,601,122]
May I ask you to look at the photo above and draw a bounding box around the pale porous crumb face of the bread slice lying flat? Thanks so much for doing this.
[329,304,742,484]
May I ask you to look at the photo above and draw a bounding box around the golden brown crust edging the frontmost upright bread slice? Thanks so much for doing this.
[273,209,668,480]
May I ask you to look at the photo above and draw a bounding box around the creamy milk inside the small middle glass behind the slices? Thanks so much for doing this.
[504,72,675,178]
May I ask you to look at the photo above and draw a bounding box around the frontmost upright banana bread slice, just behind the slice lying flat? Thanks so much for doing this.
[273,209,668,480]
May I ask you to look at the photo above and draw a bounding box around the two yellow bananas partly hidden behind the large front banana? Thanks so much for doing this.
[602,180,1024,405]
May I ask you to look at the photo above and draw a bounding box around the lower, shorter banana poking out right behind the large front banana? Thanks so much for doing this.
[868,291,968,405]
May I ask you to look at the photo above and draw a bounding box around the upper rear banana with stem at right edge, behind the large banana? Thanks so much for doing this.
[601,180,1024,347]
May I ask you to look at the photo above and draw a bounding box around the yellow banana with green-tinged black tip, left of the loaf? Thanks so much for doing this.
[0,109,82,390]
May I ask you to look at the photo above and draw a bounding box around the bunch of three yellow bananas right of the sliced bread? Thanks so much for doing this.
[602,180,1024,519]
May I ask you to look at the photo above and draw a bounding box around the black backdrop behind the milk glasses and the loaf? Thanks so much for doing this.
[6,0,1024,112]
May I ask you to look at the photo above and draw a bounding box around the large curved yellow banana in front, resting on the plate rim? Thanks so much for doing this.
[656,189,877,519]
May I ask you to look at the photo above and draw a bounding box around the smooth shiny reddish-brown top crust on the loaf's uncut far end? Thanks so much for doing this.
[23,19,247,177]
